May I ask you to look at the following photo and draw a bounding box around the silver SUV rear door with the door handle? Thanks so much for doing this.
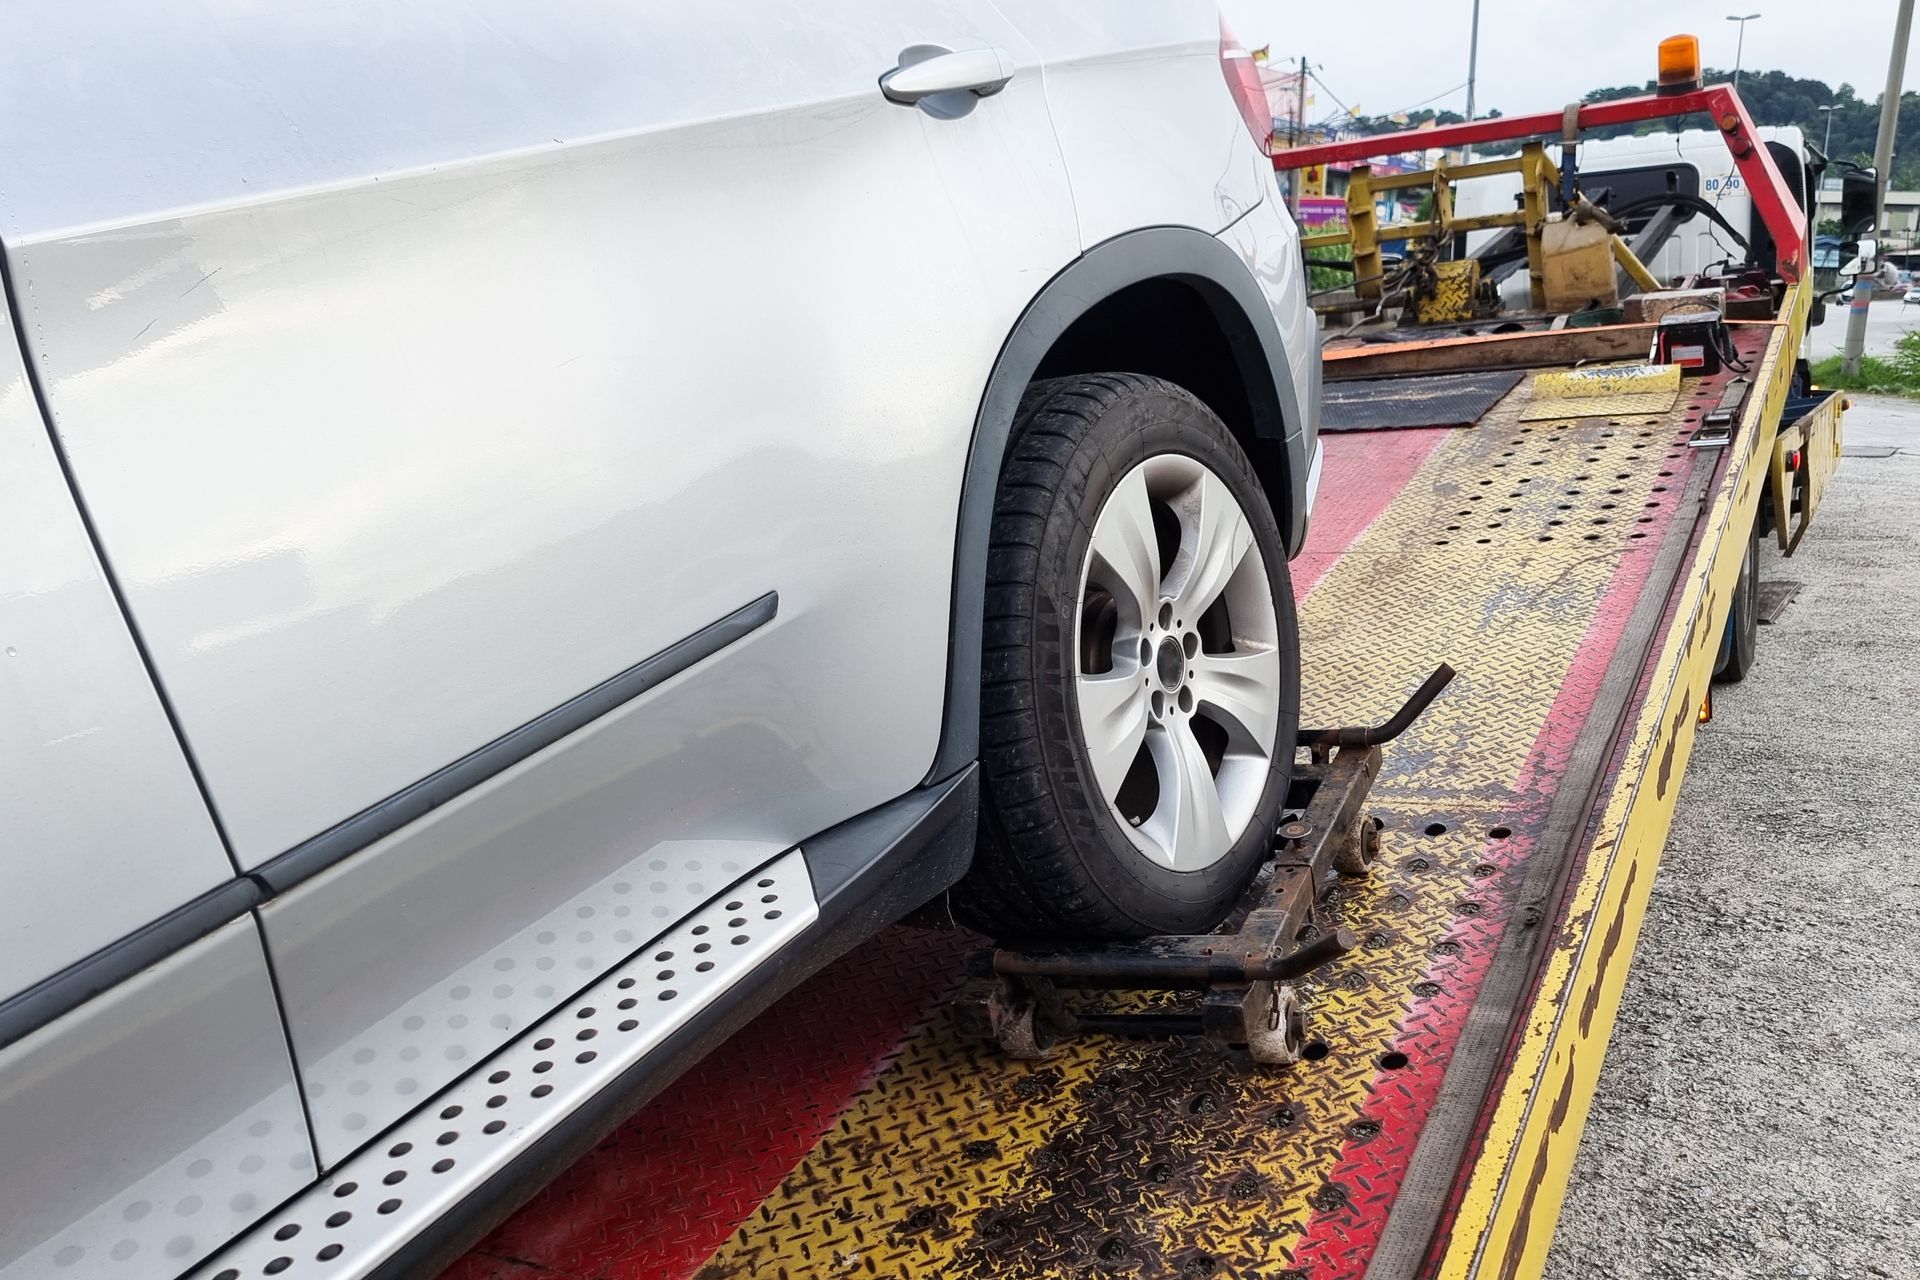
[0,0,1077,1163]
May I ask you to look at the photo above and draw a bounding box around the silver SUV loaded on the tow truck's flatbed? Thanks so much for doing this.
[0,0,1319,1280]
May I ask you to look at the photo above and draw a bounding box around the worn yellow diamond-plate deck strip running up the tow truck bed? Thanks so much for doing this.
[701,334,1784,1280]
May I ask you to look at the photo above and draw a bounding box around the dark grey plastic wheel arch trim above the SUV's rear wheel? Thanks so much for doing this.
[927,226,1306,781]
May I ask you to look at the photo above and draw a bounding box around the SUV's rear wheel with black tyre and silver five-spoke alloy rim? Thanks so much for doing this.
[954,374,1300,938]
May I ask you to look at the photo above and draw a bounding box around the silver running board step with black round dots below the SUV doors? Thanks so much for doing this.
[192,850,818,1280]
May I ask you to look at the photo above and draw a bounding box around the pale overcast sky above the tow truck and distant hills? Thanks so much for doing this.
[1221,0,1920,119]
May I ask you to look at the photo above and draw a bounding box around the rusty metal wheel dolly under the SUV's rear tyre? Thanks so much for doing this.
[952,664,1453,1063]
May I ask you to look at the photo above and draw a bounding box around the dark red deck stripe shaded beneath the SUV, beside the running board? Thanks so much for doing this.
[445,929,979,1280]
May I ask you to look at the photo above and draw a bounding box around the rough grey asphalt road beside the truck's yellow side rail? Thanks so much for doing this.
[1546,395,1920,1280]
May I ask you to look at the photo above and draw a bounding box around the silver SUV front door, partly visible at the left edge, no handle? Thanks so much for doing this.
[0,305,313,1280]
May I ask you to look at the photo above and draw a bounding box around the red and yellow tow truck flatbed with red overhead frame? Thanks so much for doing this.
[435,52,1843,1280]
